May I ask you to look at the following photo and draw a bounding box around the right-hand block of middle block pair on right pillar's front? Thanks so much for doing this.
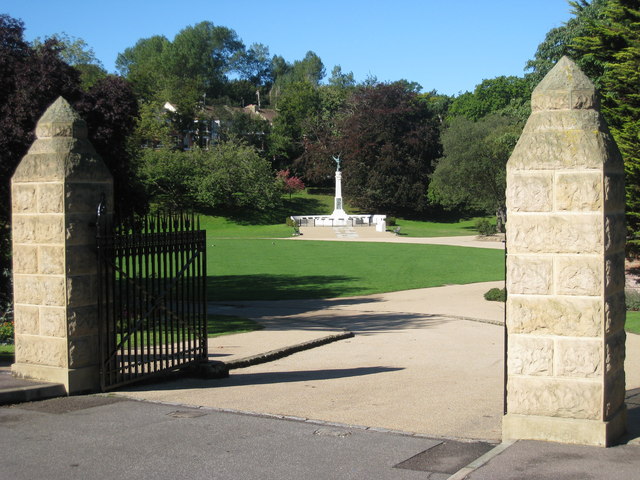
[556,255,603,296]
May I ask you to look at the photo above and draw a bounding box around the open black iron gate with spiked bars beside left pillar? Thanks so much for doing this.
[97,202,207,390]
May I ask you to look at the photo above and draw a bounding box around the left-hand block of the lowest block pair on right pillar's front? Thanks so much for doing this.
[508,335,553,375]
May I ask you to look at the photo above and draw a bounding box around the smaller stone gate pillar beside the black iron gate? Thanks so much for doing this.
[11,97,113,393]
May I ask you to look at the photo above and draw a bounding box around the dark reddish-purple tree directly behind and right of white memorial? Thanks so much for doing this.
[333,83,441,214]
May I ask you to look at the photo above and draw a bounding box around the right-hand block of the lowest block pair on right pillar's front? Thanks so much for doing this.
[554,338,604,378]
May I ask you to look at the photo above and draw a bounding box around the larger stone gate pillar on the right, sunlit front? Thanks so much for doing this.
[503,57,626,446]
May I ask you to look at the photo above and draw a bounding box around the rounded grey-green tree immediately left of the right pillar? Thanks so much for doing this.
[428,114,523,229]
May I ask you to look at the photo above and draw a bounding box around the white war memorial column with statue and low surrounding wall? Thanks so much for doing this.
[291,155,387,232]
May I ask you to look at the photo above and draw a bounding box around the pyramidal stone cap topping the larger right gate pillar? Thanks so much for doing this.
[531,57,600,112]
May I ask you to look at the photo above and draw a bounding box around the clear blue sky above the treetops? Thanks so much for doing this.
[0,0,571,95]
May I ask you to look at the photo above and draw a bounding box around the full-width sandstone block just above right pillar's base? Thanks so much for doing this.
[507,377,603,420]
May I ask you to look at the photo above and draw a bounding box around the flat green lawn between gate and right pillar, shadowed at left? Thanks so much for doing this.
[207,238,504,301]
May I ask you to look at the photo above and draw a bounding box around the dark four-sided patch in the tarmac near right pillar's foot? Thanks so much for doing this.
[396,440,495,474]
